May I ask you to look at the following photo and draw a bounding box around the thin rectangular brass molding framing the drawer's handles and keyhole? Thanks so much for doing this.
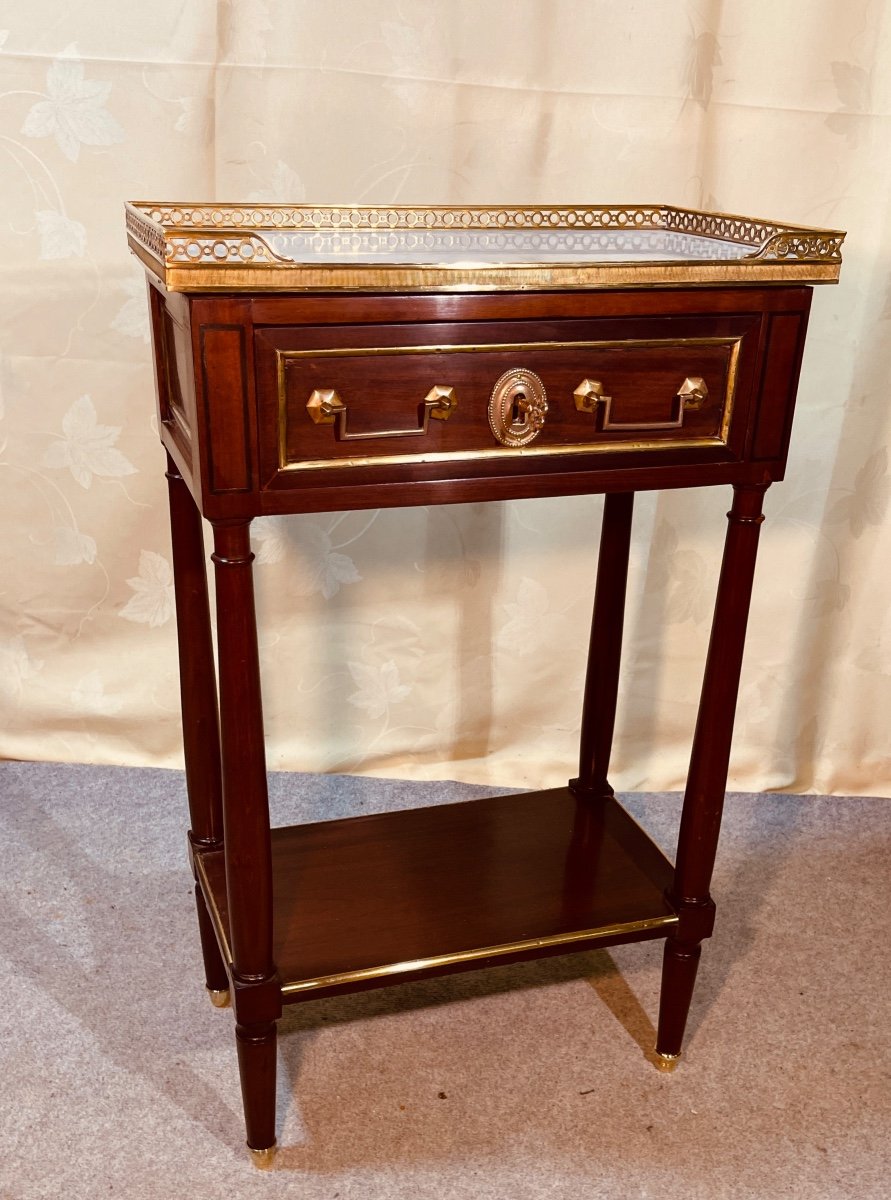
[275,334,743,472]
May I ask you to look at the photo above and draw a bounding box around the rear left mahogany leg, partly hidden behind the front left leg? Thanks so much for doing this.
[167,455,229,1002]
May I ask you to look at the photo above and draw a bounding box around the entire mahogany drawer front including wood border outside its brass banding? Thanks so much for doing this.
[256,314,758,486]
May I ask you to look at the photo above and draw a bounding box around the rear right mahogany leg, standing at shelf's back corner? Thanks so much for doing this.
[569,492,634,797]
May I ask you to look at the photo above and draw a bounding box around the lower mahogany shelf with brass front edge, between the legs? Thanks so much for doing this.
[196,788,677,1002]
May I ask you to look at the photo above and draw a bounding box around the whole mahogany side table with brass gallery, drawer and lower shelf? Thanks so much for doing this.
[126,203,844,1165]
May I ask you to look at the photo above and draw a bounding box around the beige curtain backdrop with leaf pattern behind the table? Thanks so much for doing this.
[0,0,891,794]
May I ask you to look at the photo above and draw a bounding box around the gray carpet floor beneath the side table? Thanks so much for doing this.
[0,763,891,1200]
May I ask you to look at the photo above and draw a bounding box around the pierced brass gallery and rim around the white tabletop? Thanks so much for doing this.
[125,200,845,292]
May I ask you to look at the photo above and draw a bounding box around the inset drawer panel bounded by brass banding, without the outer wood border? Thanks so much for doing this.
[271,331,745,472]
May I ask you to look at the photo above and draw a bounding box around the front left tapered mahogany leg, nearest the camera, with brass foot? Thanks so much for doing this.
[213,521,281,1152]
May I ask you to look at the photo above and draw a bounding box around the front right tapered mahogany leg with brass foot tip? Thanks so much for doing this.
[656,485,766,1067]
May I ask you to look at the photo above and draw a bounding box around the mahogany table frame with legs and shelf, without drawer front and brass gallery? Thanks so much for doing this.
[150,274,811,1160]
